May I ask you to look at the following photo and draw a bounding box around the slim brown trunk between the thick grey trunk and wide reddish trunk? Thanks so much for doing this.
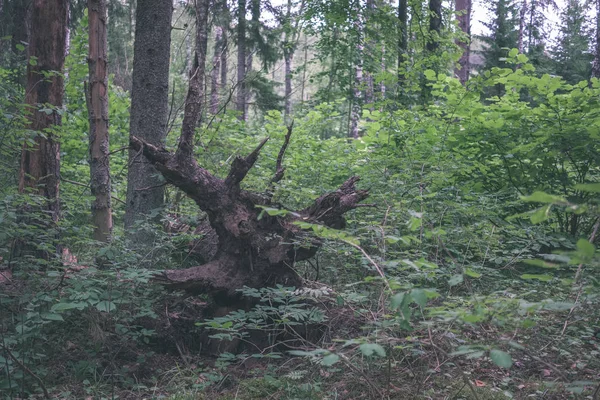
[86,0,113,242]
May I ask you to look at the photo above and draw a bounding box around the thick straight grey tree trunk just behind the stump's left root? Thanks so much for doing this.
[125,0,173,234]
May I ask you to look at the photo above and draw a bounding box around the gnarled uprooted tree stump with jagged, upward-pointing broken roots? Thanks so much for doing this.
[130,0,368,298]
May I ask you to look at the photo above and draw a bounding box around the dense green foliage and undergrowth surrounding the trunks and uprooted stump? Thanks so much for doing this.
[0,0,600,400]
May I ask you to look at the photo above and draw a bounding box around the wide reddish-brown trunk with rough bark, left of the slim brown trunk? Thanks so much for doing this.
[19,0,69,228]
